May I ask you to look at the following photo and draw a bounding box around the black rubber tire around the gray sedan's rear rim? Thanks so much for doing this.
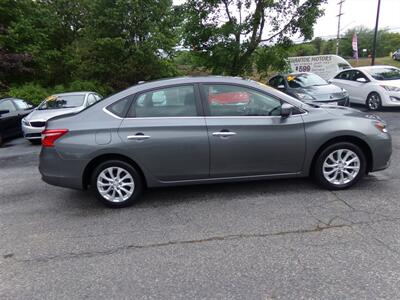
[91,160,144,208]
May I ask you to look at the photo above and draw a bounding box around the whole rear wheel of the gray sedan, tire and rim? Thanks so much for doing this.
[91,160,143,208]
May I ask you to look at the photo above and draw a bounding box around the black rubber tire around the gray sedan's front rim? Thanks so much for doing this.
[313,142,367,190]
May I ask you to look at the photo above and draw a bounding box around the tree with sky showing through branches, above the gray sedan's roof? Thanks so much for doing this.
[183,0,326,75]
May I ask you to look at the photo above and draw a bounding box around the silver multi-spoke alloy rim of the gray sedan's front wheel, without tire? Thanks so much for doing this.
[322,149,361,185]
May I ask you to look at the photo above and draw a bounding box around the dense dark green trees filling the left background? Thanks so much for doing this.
[0,0,180,94]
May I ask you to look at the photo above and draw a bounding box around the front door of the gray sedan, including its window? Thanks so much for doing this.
[202,84,305,177]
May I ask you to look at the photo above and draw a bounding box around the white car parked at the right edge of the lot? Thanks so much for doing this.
[330,66,400,110]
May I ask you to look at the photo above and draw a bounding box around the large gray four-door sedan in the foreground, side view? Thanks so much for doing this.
[39,77,392,207]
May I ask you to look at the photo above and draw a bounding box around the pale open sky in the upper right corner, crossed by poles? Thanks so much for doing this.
[173,0,400,38]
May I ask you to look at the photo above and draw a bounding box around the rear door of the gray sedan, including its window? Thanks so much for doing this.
[115,85,209,181]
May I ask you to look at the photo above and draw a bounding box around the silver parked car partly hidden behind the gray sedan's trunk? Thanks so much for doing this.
[22,92,102,144]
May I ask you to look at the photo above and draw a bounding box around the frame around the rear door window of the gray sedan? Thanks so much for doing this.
[124,83,204,119]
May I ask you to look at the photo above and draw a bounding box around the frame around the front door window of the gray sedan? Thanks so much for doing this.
[199,82,307,118]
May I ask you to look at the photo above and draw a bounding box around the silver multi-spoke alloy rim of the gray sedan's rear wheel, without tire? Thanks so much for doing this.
[96,167,135,203]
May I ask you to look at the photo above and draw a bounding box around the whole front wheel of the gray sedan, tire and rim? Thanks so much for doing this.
[314,142,366,190]
